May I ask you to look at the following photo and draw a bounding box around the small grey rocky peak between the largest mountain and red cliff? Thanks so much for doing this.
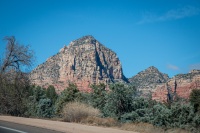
[129,66,169,96]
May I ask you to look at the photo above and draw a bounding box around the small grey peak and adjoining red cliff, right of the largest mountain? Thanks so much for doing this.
[129,67,200,102]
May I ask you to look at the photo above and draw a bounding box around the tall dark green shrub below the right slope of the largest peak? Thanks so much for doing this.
[103,83,136,119]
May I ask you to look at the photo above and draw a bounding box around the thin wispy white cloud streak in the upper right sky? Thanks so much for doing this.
[138,6,200,24]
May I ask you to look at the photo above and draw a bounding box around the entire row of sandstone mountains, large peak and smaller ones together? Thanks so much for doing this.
[29,36,200,102]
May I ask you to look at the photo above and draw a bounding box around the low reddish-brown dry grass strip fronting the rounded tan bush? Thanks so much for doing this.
[81,116,119,127]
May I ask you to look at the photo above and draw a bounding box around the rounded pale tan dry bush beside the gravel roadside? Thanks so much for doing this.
[62,102,100,122]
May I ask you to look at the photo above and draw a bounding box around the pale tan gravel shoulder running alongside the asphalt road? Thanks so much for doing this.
[0,116,136,133]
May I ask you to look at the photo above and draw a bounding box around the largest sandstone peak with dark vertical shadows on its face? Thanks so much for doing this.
[30,36,127,91]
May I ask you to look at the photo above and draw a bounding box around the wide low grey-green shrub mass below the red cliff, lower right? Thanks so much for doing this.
[120,97,200,132]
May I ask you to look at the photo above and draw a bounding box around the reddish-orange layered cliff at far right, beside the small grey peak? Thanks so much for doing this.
[152,70,200,102]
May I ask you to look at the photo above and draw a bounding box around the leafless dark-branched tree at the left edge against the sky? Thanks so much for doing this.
[0,36,34,115]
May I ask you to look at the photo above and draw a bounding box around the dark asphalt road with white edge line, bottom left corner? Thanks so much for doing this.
[0,121,64,133]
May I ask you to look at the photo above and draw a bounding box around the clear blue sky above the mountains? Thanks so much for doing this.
[0,0,200,77]
